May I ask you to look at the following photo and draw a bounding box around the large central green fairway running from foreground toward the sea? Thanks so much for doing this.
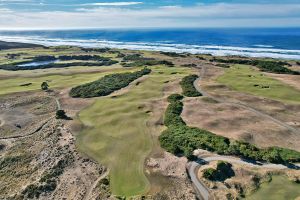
[77,67,191,197]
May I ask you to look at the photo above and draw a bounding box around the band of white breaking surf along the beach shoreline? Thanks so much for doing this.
[0,36,300,60]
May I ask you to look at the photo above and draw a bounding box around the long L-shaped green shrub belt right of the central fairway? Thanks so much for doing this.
[159,94,300,164]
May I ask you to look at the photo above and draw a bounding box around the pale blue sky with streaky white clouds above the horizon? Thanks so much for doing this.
[0,0,300,29]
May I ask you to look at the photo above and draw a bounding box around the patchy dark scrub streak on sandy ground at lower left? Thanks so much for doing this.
[21,154,74,199]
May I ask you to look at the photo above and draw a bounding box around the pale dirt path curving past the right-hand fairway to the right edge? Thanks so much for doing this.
[194,66,300,134]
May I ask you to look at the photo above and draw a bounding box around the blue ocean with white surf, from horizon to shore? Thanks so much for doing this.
[0,28,300,60]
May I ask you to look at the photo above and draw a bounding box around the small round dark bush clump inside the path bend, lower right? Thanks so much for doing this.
[203,161,235,181]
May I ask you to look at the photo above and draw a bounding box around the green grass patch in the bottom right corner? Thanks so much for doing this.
[246,176,300,200]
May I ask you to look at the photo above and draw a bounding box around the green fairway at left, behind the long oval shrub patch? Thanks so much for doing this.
[0,67,132,95]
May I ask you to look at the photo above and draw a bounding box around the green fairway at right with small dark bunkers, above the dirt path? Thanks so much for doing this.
[217,65,300,103]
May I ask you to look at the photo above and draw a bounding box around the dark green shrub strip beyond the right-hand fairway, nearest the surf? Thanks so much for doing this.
[210,58,300,75]
